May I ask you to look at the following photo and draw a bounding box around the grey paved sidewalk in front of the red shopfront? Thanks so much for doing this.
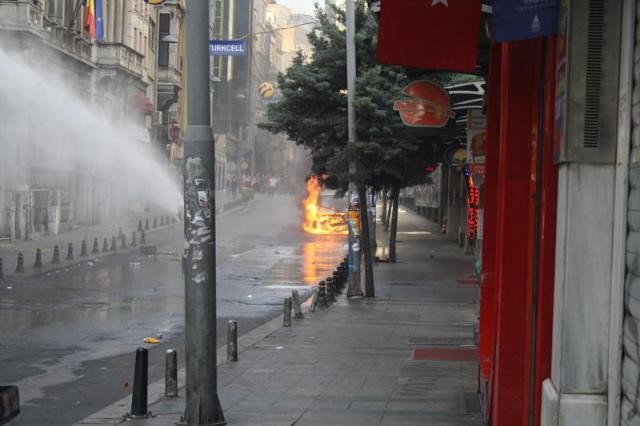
[79,210,483,426]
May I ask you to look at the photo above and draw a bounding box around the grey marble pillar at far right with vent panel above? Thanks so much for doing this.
[540,0,640,426]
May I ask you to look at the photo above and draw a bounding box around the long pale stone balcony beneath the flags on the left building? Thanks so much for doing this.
[0,0,92,63]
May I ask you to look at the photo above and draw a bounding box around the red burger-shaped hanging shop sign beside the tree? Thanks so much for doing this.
[393,80,456,128]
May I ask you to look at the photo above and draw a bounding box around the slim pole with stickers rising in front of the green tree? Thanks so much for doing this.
[346,0,364,297]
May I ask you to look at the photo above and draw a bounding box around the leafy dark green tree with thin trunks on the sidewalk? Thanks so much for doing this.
[260,0,436,296]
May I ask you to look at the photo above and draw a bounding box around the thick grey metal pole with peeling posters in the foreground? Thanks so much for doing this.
[182,1,226,426]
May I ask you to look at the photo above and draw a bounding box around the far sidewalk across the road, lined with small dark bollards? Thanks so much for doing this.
[0,191,248,278]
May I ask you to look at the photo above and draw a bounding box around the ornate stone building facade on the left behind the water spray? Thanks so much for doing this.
[0,0,184,239]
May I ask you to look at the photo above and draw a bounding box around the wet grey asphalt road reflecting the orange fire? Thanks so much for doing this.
[0,196,346,426]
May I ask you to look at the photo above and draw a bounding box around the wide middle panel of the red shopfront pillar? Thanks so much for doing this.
[490,41,538,426]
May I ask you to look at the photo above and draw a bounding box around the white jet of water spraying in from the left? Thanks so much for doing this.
[0,51,182,223]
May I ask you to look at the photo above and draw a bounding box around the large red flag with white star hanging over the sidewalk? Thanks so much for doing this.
[377,0,482,71]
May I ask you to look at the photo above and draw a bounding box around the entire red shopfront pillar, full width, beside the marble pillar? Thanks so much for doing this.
[478,39,557,426]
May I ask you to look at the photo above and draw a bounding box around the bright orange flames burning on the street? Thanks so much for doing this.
[302,176,348,235]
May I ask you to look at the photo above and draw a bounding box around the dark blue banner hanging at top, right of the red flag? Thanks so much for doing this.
[493,0,560,42]
